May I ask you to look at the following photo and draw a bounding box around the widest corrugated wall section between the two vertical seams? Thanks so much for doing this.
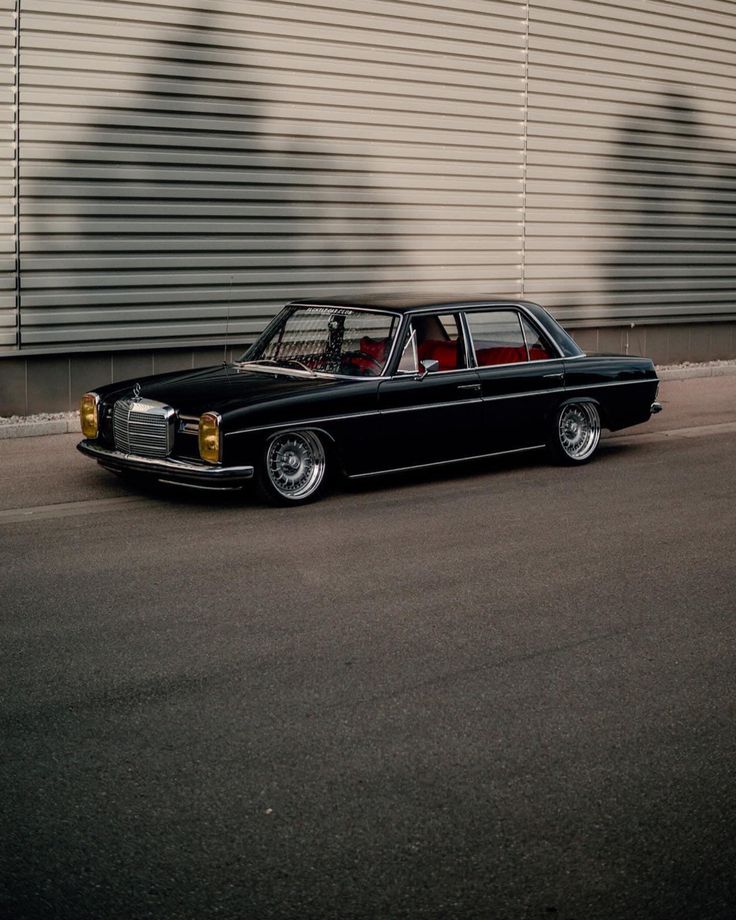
[21,0,525,348]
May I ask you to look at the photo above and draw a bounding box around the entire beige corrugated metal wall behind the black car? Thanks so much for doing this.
[0,0,736,353]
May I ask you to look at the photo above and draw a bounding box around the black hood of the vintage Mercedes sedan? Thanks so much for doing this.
[111,364,347,415]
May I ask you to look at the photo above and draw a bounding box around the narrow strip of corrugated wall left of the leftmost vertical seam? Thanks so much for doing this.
[0,0,18,348]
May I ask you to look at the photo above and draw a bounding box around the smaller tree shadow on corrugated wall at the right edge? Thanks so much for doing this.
[606,92,736,356]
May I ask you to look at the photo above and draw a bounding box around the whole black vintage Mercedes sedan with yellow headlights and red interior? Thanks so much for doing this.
[78,300,660,505]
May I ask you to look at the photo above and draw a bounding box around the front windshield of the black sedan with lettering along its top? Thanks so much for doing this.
[240,306,399,377]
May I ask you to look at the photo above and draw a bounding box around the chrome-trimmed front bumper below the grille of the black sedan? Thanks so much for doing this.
[77,440,254,489]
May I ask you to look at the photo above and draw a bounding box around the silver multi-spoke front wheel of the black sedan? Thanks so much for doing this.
[258,431,327,505]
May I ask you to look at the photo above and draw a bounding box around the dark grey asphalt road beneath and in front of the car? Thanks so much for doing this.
[0,378,736,920]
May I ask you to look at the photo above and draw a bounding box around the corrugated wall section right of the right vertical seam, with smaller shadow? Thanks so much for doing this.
[525,0,736,325]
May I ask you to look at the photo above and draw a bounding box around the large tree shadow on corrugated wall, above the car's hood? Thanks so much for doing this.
[24,4,402,345]
